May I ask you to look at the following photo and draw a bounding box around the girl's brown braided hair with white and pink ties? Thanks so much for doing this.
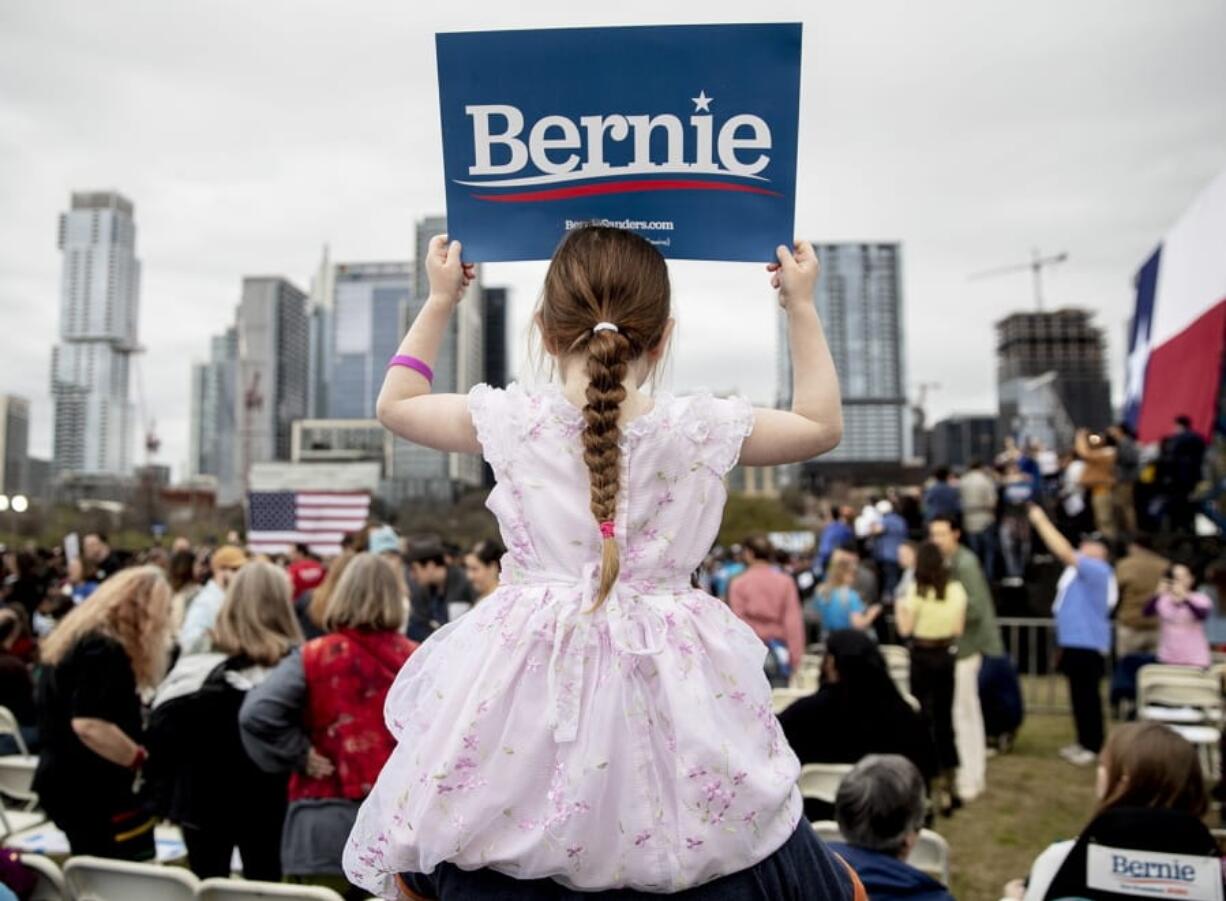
[535,226,671,607]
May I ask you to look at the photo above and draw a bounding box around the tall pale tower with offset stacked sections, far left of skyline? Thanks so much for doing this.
[51,191,141,476]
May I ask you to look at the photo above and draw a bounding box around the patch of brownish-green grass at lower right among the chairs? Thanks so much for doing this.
[935,715,1095,901]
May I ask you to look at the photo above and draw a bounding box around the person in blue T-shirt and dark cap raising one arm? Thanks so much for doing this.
[1030,504,1119,766]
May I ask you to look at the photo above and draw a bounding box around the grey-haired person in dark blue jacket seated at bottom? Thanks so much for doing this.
[830,754,953,901]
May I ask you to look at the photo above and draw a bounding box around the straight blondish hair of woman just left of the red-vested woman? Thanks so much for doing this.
[213,560,303,667]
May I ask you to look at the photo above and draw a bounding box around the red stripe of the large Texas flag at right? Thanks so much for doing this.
[1137,298,1226,443]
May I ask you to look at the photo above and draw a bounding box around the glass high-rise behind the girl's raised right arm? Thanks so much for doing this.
[777,244,912,463]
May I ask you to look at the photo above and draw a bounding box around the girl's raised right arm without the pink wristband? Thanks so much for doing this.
[741,241,842,466]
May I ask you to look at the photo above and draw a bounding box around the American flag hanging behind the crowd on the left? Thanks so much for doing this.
[246,492,370,557]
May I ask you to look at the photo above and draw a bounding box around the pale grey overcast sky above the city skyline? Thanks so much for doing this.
[0,0,1226,480]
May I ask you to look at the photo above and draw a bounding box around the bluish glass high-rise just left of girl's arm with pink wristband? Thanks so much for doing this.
[328,262,413,419]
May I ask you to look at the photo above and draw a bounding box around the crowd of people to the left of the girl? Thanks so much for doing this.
[0,525,505,897]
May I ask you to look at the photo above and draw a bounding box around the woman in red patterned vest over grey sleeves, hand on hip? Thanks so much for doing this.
[239,553,417,897]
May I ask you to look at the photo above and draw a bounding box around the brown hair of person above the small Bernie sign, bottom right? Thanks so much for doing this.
[1095,721,1209,818]
